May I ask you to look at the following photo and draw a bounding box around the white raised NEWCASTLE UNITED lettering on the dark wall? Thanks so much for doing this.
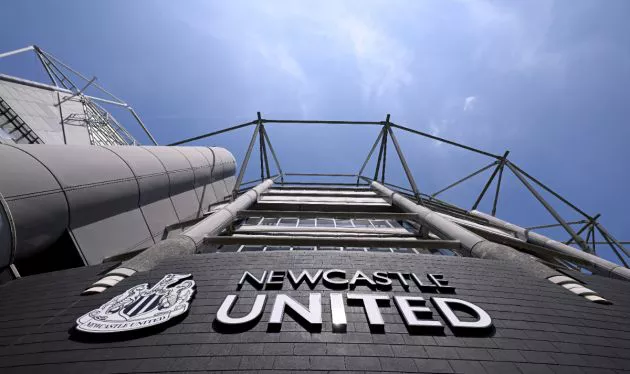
[215,269,492,333]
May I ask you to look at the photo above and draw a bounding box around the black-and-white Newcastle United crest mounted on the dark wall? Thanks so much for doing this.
[77,274,195,333]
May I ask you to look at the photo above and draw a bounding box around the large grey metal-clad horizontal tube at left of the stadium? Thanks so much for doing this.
[0,145,236,266]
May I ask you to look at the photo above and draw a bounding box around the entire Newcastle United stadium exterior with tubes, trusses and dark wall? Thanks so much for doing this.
[0,47,630,373]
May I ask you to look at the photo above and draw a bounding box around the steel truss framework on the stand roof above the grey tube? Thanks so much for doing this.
[0,45,157,145]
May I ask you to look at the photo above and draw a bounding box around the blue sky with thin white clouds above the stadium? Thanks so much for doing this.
[0,0,630,264]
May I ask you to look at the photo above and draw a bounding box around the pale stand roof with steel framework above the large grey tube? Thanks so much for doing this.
[0,45,157,145]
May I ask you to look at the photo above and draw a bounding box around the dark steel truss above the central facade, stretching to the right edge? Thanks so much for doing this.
[168,112,630,268]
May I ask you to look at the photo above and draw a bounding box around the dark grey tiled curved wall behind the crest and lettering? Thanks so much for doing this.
[0,252,630,373]
